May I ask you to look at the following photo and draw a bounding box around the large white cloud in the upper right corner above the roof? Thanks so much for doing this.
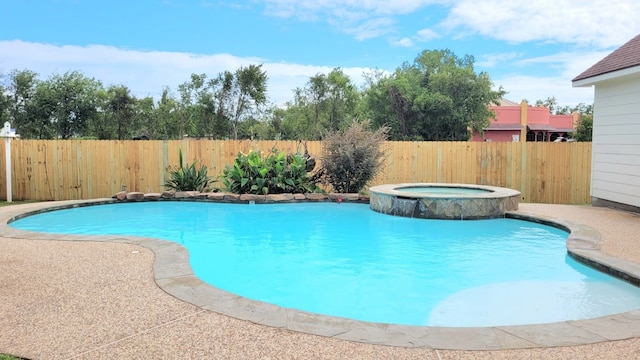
[440,0,640,48]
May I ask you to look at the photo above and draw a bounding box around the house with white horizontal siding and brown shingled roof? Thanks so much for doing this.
[572,35,640,212]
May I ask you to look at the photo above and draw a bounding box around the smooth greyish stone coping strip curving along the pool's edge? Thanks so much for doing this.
[0,199,640,350]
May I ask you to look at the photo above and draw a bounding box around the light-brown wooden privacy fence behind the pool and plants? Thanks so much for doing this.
[0,140,591,204]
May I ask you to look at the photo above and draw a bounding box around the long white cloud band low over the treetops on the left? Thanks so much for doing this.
[0,40,368,104]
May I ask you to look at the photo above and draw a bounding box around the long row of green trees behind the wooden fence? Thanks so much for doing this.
[0,49,590,141]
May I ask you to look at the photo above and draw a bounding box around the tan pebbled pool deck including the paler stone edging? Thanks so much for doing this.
[0,201,640,359]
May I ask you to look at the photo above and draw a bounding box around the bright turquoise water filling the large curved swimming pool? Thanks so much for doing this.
[11,202,640,326]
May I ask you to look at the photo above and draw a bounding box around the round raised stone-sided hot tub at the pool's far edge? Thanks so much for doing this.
[369,183,520,220]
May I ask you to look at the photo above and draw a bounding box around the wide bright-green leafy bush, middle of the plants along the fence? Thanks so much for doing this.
[220,148,317,195]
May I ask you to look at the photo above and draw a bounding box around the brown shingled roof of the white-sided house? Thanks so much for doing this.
[572,35,640,82]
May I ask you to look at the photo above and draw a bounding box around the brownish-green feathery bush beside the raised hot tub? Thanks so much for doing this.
[321,121,389,193]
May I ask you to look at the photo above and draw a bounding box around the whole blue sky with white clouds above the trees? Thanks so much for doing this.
[0,0,640,105]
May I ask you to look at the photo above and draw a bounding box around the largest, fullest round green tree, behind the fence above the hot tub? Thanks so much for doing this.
[365,50,505,141]
